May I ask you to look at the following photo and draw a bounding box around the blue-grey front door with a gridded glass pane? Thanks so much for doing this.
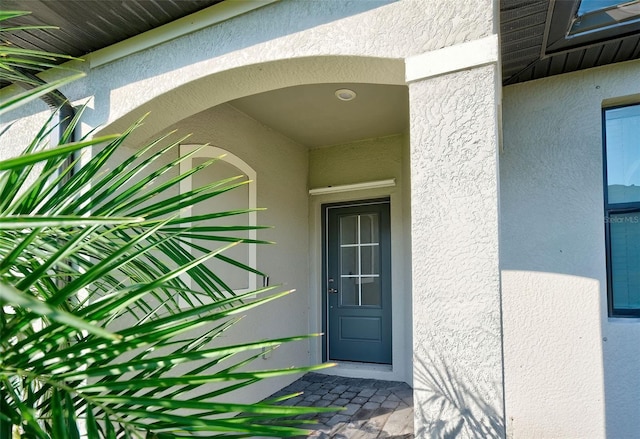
[324,200,391,364]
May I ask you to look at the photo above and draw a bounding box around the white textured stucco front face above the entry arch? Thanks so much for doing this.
[88,0,493,131]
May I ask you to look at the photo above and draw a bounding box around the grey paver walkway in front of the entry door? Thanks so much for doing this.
[272,373,413,439]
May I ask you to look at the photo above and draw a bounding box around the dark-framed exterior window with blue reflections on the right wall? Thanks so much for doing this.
[604,105,640,316]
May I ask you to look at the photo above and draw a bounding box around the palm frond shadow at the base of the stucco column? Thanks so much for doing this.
[413,353,505,439]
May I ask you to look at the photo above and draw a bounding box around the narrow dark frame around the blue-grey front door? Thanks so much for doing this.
[320,197,393,365]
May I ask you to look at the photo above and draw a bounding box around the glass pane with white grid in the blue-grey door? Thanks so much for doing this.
[339,213,381,307]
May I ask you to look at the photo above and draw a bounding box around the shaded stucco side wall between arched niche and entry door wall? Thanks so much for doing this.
[160,105,309,401]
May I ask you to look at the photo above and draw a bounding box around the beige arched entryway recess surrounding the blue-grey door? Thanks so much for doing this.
[95,57,411,392]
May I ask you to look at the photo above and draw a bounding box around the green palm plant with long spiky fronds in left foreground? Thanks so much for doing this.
[0,12,327,439]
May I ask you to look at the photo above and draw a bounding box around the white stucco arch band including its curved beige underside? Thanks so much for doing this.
[1,0,493,148]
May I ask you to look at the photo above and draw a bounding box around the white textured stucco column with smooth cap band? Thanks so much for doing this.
[407,35,505,438]
